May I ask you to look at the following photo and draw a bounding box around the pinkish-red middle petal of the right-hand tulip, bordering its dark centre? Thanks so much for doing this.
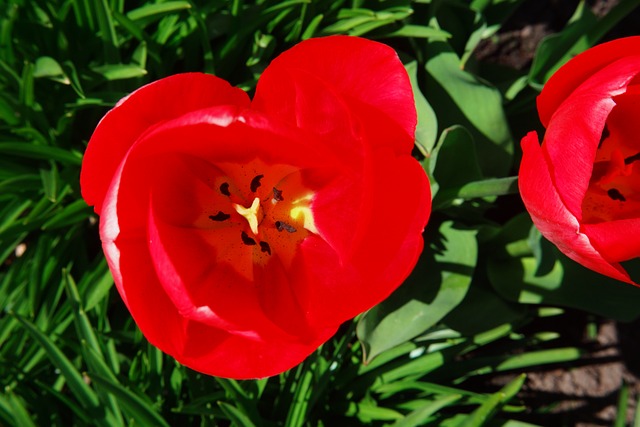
[542,56,640,221]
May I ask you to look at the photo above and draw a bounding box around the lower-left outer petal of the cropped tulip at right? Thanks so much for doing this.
[518,132,633,283]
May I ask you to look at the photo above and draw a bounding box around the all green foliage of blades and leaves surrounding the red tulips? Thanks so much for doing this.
[0,0,640,427]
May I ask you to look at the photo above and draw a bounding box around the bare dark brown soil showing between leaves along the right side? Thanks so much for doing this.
[475,0,640,427]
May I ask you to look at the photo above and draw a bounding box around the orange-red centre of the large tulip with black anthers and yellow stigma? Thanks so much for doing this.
[198,159,317,278]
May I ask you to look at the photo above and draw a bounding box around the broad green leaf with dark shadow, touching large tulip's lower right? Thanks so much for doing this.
[357,222,478,363]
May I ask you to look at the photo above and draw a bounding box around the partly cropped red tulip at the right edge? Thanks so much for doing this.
[519,37,640,284]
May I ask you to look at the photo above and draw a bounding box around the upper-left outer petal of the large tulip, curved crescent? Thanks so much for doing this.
[80,73,249,214]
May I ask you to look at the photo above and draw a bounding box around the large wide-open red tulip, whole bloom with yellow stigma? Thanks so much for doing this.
[81,36,431,378]
